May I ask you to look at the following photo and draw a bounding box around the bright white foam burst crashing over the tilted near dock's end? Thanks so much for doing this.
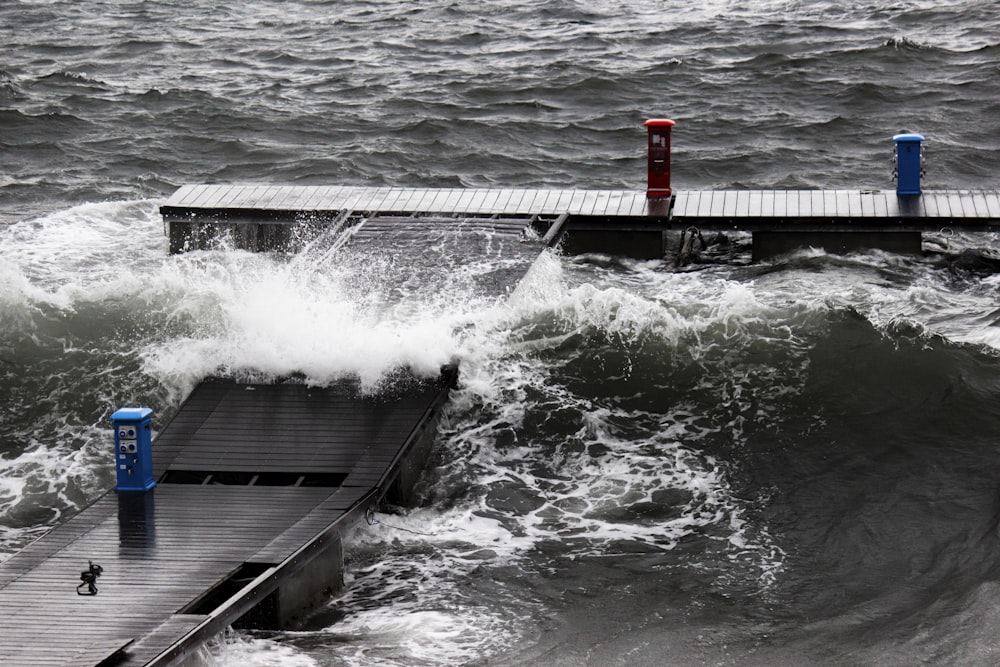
[143,253,456,396]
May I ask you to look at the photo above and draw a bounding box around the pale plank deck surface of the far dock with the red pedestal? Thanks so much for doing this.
[161,185,1000,224]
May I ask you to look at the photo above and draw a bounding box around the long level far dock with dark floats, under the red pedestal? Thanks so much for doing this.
[160,185,1000,258]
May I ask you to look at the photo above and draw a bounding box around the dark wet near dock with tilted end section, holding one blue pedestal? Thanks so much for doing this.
[0,371,455,667]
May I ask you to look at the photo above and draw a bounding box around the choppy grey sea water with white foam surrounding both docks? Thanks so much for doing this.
[0,0,1000,667]
